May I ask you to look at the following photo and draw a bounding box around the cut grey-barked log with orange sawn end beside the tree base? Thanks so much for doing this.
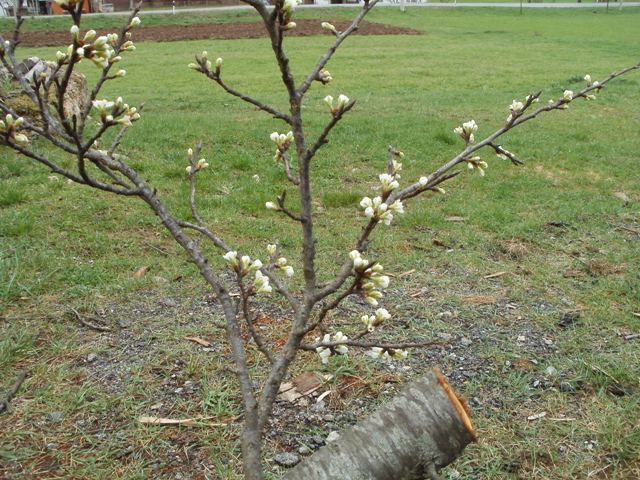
[284,370,477,480]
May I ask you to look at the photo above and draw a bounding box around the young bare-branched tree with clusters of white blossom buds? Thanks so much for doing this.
[0,0,640,480]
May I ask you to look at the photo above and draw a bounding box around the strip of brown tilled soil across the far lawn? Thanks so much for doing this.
[10,20,422,47]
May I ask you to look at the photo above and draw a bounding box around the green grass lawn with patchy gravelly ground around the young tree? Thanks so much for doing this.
[0,8,640,479]
